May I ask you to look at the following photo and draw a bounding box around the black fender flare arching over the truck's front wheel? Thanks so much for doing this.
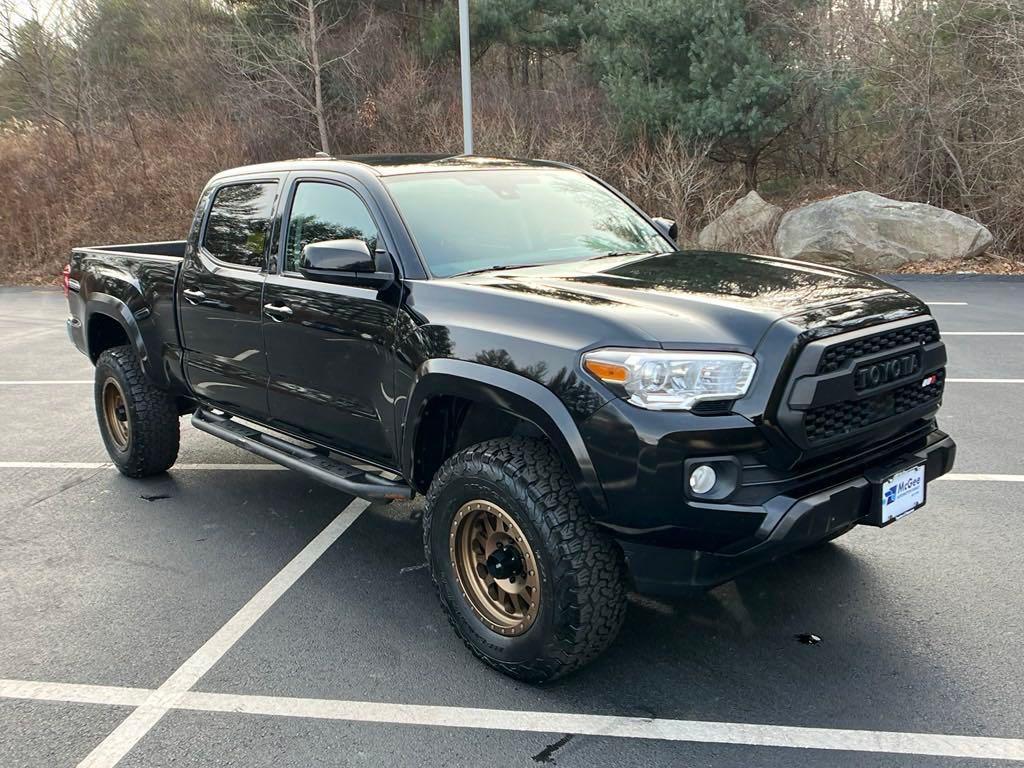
[401,358,607,517]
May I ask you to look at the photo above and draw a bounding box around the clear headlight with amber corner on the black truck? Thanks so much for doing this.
[583,349,757,411]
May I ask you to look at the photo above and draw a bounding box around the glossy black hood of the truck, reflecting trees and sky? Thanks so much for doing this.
[450,251,928,349]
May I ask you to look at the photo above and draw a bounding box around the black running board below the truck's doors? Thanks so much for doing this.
[191,409,413,500]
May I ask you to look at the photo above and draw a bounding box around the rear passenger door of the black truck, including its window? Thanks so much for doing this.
[178,175,283,420]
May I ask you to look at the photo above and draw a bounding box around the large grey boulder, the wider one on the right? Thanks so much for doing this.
[775,191,992,271]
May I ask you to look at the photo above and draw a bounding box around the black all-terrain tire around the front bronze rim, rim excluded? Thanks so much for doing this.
[423,437,626,683]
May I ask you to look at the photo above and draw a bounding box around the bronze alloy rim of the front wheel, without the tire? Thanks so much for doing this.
[449,500,541,636]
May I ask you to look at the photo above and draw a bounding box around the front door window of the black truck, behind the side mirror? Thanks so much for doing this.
[285,181,378,272]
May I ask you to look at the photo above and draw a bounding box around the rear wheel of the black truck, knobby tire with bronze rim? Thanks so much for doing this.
[94,346,180,477]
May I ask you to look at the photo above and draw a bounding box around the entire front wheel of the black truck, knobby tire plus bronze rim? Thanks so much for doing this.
[423,438,626,683]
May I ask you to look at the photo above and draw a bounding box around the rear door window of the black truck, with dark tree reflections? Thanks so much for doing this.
[203,181,278,266]
